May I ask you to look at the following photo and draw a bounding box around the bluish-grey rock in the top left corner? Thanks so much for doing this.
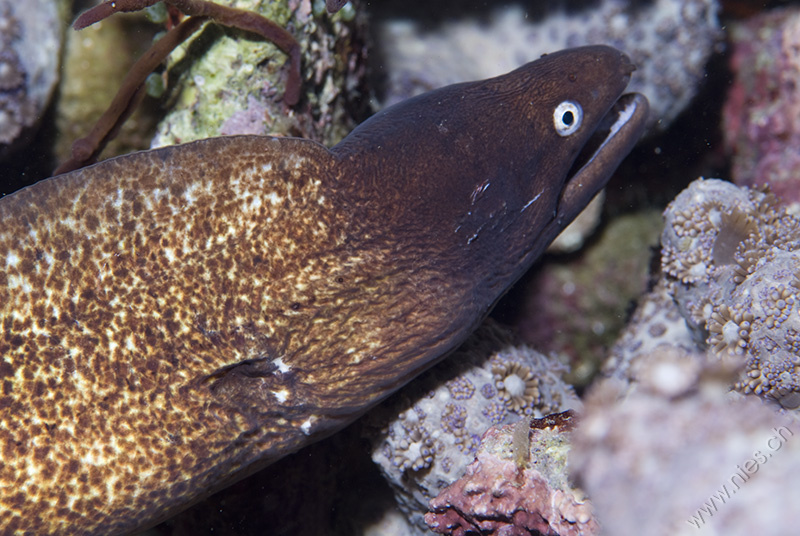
[0,0,64,159]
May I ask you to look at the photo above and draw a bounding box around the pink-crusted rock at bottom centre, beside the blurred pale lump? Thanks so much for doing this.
[425,411,600,536]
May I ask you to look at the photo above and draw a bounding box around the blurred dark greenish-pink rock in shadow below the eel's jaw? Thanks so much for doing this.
[517,210,662,386]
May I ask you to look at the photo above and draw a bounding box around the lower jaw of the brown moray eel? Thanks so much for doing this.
[556,93,650,226]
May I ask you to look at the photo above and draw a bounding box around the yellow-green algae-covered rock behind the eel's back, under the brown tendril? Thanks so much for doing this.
[153,0,365,147]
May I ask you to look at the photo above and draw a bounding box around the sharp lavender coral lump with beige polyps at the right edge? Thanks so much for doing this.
[662,179,800,408]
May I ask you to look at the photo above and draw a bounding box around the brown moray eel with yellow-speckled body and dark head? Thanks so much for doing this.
[0,46,647,535]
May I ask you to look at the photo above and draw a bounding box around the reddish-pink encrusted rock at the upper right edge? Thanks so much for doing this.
[723,6,800,209]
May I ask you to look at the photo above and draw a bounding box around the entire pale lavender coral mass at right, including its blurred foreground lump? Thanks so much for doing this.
[592,179,800,536]
